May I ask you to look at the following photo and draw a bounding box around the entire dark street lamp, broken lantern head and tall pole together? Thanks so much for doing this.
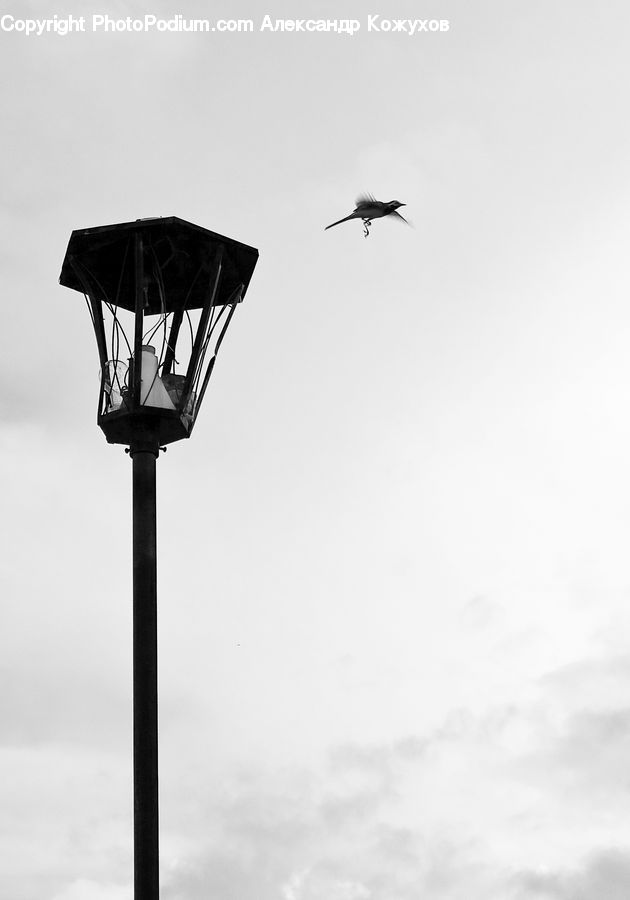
[59,217,258,900]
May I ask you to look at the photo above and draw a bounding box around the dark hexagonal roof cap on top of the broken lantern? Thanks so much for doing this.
[59,216,258,315]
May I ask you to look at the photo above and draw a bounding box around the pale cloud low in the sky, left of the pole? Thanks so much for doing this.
[0,745,133,900]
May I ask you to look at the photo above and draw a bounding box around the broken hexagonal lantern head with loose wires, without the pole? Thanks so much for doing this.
[59,216,258,454]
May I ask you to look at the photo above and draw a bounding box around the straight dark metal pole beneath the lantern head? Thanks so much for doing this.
[129,440,160,900]
